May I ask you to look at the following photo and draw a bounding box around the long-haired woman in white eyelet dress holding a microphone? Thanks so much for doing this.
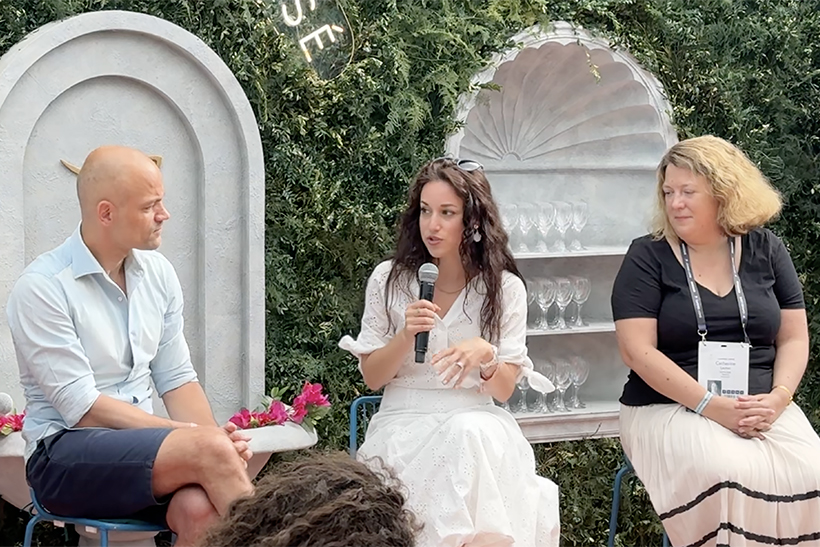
[339,158,560,547]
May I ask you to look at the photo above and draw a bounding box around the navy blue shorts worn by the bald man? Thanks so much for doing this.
[26,428,172,525]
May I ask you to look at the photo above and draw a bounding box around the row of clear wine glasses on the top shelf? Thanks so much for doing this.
[499,201,589,253]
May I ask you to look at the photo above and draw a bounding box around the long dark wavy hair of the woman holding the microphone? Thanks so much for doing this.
[384,158,524,343]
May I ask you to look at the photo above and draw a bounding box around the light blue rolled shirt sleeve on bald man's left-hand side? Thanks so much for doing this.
[6,273,100,427]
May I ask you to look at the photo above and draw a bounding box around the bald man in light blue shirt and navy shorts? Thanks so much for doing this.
[6,146,252,546]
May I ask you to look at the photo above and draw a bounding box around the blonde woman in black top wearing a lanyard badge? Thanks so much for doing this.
[612,136,820,547]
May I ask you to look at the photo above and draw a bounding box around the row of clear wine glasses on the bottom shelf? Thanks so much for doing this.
[502,355,589,414]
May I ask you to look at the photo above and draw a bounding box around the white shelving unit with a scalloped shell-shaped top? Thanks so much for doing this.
[446,22,677,442]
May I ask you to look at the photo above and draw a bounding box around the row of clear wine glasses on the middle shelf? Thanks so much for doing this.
[527,275,592,330]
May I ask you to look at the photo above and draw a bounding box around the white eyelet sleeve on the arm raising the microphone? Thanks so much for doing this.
[339,263,395,368]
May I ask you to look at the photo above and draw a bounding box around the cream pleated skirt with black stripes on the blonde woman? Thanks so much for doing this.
[620,403,820,547]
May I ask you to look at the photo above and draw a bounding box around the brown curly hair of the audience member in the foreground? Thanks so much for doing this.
[195,453,420,547]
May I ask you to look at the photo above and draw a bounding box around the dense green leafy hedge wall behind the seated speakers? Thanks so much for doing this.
[0,0,820,545]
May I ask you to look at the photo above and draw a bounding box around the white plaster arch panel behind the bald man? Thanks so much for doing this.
[0,11,265,421]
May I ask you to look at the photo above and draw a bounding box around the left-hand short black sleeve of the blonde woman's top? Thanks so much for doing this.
[610,238,662,321]
